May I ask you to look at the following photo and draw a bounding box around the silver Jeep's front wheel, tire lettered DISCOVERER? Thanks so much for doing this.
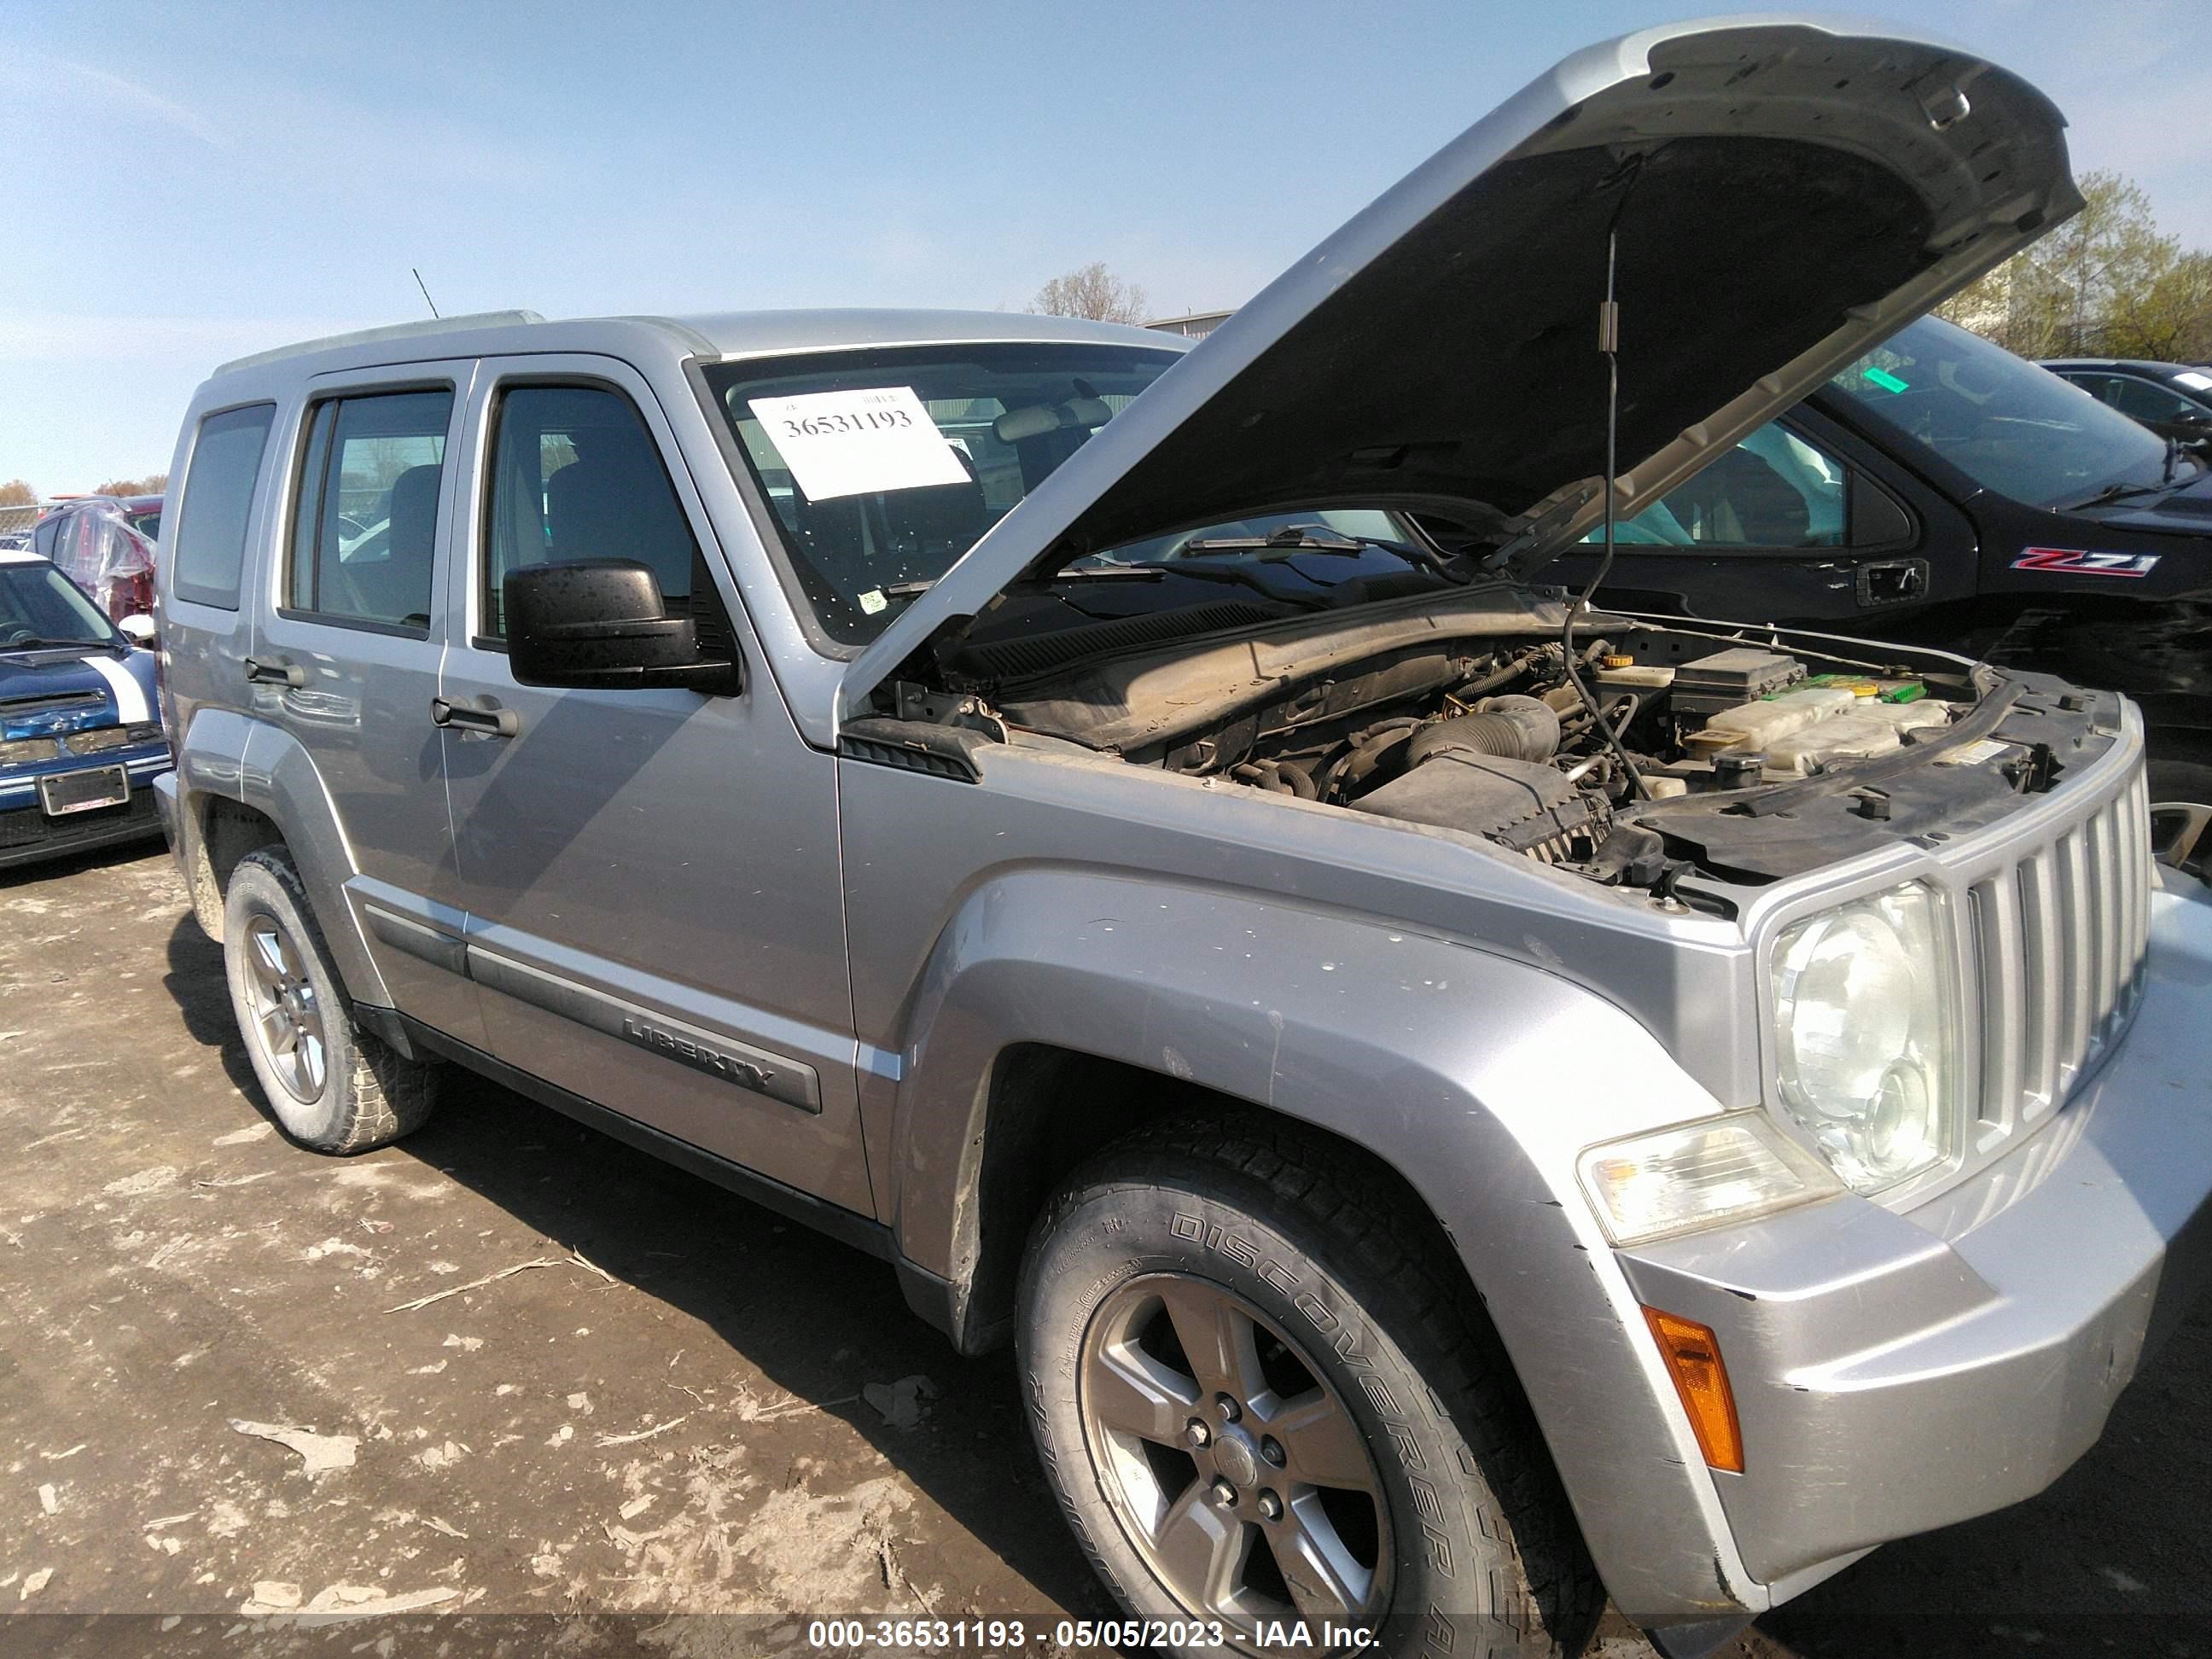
[1020,1120,1602,1655]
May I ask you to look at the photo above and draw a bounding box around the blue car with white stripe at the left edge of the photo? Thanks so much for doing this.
[0,553,168,870]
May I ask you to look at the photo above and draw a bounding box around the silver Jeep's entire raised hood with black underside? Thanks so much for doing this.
[838,15,2081,719]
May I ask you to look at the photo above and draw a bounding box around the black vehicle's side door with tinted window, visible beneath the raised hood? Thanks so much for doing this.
[1557,407,1976,632]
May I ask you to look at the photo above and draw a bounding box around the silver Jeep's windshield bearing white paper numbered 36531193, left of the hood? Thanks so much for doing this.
[706,345,1179,643]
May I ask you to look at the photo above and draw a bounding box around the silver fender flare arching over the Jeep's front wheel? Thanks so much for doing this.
[892,867,1765,1621]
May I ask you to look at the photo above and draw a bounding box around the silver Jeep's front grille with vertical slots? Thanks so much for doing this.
[1966,765,2150,1150]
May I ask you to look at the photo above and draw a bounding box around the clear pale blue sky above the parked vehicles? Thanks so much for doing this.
[0,0,2212,491]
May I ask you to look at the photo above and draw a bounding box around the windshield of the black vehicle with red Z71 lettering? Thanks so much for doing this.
[1830,317,2190,507]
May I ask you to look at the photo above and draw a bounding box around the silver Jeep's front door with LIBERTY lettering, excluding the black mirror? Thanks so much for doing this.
[442,356,871,1212]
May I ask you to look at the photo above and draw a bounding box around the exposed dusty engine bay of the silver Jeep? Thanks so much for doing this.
[867,593,2119,905]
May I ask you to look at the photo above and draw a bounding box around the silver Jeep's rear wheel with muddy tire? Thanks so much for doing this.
[224,847,438,1155]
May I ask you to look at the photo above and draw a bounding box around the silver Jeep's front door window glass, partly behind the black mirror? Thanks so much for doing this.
[482,385,699,639]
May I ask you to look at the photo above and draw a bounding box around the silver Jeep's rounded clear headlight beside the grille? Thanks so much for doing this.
[1772,882,1958,1192]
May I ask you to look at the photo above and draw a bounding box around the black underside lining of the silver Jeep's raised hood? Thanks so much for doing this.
[1053,137,1933,557]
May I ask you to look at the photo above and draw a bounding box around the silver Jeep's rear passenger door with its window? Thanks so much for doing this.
[247,363,482,1042]
